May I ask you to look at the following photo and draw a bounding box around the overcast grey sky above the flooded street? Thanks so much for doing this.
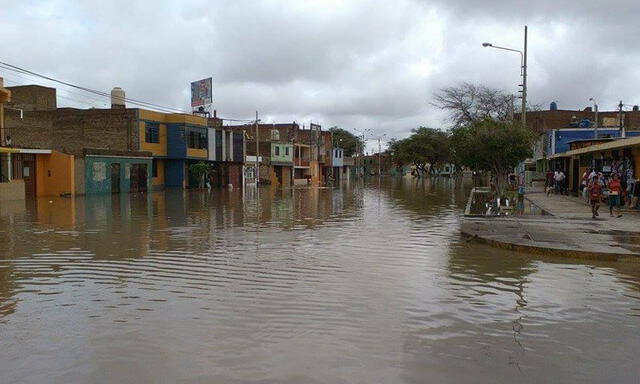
[0,0,640,151]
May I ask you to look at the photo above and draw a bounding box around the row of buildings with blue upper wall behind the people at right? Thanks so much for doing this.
[524,103,640,193]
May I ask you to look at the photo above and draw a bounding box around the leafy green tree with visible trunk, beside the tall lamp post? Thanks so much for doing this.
[451,118,534,196]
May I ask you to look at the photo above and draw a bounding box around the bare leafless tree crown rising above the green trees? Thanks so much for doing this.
[432,83,514,128]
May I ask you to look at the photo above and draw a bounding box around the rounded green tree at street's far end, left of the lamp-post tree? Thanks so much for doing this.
[388,127,451,175]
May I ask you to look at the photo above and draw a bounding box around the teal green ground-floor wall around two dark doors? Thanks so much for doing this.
[84,156,153,195]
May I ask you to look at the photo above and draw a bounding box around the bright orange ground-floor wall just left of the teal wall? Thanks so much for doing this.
[36,151,75,196]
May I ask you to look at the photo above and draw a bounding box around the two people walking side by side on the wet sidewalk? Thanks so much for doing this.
[580,168,627,219]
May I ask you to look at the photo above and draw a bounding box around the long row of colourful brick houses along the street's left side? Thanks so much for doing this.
[0,78,348,200]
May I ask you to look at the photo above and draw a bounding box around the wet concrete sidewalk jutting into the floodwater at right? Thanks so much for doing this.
[461,192,640,261]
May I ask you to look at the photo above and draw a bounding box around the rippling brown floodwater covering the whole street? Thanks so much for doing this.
[0,179,640,383]
